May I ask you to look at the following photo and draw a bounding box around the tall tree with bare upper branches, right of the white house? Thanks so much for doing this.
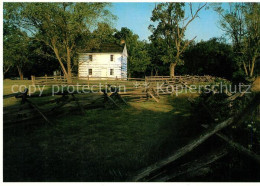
[150,3,206,77]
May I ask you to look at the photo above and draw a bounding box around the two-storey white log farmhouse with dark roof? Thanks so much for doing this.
[78,44,127,79]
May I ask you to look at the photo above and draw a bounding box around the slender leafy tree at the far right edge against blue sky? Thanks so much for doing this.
[213,3,260,77]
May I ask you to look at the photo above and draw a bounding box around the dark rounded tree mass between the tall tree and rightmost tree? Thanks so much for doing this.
[182,38,234,80]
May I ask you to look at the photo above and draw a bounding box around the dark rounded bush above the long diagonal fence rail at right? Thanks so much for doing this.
[191,81,254,125]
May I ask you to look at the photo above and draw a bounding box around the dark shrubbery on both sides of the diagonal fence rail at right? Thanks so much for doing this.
[191,87,260,153]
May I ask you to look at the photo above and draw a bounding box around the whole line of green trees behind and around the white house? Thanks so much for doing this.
[3,3,260,82]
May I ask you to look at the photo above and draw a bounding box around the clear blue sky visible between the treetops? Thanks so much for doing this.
[111,2,223,41]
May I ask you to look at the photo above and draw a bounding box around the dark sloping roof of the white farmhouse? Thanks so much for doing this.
[85,43,124,53]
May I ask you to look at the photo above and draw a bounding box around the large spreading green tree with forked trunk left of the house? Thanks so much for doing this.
[4,3,114,83]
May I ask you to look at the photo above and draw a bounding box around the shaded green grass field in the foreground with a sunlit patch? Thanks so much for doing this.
[4,80,197,181]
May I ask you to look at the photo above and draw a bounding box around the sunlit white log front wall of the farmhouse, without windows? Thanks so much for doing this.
[78,53,122,78]
